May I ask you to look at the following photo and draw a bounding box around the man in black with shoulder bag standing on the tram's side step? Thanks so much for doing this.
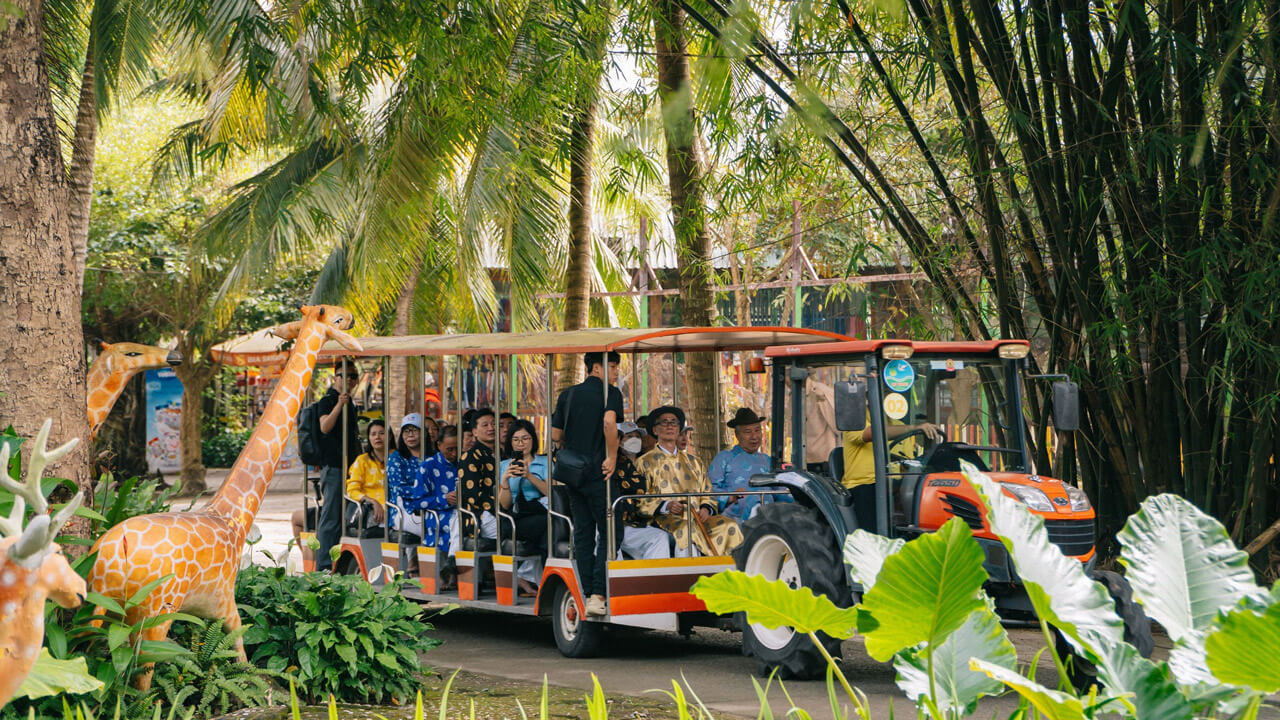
[552,352,622,615]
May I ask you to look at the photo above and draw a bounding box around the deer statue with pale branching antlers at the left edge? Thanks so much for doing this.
[0,420,84,707]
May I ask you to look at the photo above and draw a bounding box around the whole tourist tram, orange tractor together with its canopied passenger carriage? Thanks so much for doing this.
[294,328,1126,678]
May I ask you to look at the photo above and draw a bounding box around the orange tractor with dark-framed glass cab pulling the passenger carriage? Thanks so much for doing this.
[735,340,1152,678]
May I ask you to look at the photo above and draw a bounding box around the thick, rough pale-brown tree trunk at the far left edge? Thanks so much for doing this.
[0,0,90,499]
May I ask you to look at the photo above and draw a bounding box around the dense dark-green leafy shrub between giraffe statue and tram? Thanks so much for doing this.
[236,568,439,703]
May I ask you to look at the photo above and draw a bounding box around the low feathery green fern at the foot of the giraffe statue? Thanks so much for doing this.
[154,620,284,717]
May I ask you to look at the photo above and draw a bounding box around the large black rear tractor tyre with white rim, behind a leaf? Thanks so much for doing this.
[733,502,850,680]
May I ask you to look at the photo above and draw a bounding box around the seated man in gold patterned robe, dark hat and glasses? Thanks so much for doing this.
[636,406,742,557]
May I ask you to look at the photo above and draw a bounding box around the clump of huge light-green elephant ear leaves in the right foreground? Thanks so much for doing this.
[694,464,1280,720]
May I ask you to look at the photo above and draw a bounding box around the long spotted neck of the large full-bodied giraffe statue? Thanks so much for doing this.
[209,322,325,544]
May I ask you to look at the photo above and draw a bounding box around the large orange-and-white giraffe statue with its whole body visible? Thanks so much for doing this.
[90,305,362,689]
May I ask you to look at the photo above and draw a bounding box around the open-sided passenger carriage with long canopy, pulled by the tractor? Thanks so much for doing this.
[294,327,850,657]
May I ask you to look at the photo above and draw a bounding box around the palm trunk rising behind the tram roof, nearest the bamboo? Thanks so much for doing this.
[653,0,721,462]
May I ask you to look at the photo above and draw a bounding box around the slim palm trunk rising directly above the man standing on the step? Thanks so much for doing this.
[556,92,599,395]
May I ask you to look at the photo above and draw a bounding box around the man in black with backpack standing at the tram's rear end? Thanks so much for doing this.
[316,363,361,570]
